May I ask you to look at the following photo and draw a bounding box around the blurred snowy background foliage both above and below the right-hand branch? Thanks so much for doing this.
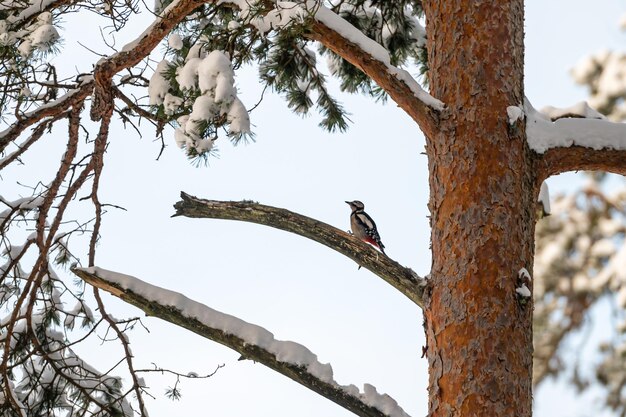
[533,23,626,416]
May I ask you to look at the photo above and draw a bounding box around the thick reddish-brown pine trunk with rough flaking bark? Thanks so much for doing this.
[424,0,537,417]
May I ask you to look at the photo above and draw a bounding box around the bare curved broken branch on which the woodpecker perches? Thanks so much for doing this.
[172,192,426,307]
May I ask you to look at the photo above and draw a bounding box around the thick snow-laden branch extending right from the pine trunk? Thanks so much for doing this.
[524,100,626,181]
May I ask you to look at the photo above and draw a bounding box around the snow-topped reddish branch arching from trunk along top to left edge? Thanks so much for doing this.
[0,0,444,146]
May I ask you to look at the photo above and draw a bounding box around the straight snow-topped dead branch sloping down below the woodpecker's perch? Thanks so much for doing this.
[72,267,408,417]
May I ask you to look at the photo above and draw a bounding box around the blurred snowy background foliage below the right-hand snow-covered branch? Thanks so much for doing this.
[533,174,626,404]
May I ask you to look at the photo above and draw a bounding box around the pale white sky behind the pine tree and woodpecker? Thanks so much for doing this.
[1,0,626,417]
